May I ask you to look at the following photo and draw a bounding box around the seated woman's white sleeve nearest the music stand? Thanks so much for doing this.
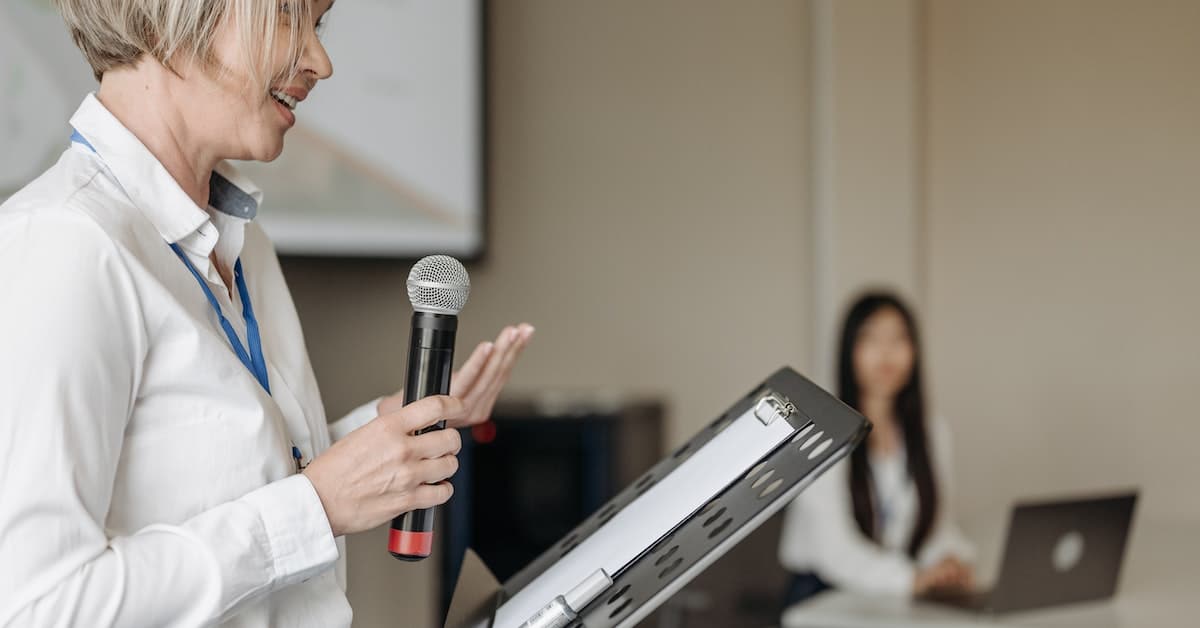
[779,463,914,596]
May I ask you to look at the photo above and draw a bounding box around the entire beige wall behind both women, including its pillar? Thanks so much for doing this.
[286,0,1200,627]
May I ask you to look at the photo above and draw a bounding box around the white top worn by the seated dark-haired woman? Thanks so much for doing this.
[779,419,974,596]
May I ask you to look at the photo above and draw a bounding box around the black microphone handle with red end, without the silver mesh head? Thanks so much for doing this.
[388,311,458,561]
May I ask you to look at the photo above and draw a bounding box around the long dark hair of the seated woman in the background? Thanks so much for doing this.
[838,293,937,557]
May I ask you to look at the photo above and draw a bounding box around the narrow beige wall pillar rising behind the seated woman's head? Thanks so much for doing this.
[808,0,923,387]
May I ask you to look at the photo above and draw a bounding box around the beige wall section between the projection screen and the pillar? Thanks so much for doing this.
[286,0,810,627]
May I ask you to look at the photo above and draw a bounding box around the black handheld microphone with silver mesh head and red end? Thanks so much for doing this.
[388,255,470,561]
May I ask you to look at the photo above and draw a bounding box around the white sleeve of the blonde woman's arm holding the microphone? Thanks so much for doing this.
[0,209,337,627]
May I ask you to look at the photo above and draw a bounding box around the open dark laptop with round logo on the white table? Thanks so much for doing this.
[928,491,1138,614]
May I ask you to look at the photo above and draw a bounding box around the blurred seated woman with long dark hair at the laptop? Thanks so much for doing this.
[779,293,974,605]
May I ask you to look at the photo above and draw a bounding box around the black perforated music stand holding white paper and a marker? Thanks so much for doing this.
[445,367,870,628]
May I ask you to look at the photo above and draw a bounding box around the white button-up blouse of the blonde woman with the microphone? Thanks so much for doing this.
[0,96,373,627]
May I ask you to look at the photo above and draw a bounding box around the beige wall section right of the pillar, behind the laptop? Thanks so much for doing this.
[925,0,1200,528]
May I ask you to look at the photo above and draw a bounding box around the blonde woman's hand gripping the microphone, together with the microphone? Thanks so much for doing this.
[304,256,470,542]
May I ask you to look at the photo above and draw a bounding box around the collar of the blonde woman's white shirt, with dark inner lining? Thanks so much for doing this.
[71,94,263,256]
